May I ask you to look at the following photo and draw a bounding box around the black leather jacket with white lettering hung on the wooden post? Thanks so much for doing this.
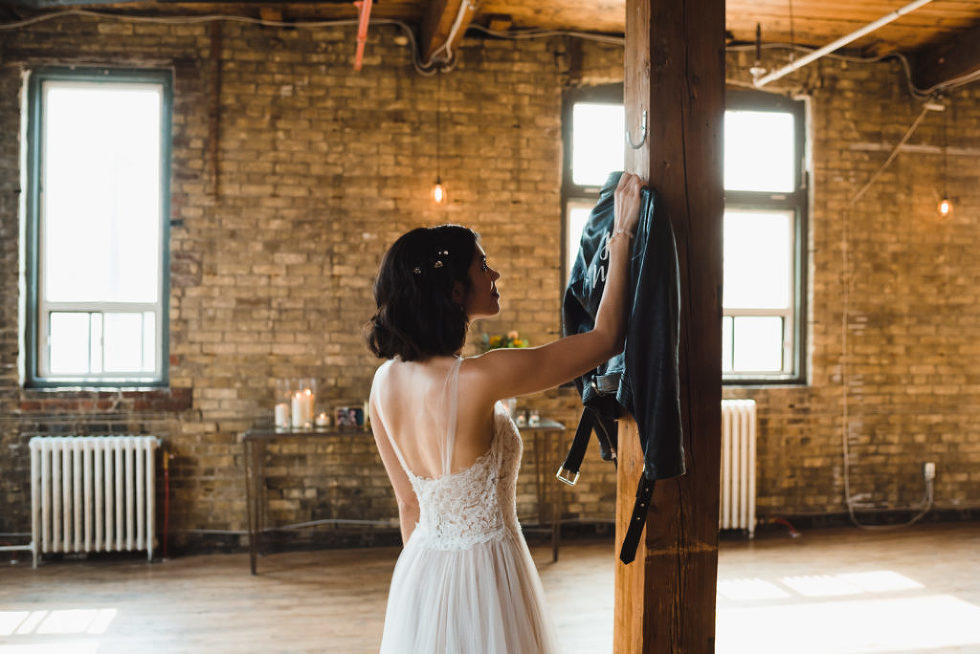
[559,172,684,564]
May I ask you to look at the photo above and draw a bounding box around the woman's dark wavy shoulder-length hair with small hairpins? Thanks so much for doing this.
[365,225,479,361]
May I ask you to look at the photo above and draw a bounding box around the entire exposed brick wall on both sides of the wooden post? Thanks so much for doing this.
[0,18,980,552]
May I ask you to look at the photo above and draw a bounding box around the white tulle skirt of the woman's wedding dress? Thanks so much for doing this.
[381,531,558,654]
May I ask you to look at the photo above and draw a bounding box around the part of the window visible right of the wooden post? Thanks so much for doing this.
[722,90,806,383]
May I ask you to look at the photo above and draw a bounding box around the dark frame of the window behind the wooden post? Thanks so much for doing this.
[559,83,810,386]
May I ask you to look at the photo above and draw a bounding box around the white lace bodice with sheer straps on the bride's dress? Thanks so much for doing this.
[378,359,523,550]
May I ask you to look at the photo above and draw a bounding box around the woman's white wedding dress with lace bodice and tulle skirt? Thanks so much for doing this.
[381,359,558,654]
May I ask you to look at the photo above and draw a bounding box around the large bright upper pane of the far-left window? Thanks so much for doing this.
[42,81,162,302]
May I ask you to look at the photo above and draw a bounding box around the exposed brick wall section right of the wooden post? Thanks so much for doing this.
[725,51,980,516]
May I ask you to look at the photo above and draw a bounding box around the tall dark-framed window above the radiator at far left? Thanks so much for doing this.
[25,68,171,386]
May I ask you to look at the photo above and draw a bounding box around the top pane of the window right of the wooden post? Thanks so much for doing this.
[725,111,796,193]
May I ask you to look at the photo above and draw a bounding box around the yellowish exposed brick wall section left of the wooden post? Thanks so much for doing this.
[0,18,615,548]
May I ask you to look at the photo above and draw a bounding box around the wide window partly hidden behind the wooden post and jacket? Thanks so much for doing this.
[563,85,806,383]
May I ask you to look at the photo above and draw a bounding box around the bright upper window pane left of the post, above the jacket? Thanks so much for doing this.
[572,102,626,186]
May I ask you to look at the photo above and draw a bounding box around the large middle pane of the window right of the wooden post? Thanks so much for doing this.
[724,210,795,309]
